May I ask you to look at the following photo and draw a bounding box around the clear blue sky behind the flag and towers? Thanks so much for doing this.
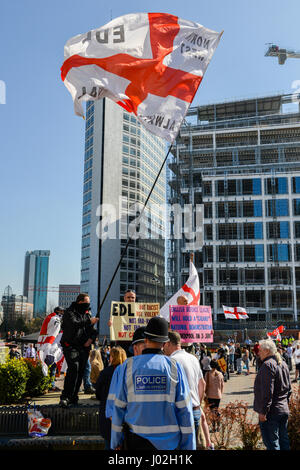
[0,0,300,303]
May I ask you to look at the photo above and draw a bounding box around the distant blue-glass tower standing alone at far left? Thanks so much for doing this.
[23,250,50,316]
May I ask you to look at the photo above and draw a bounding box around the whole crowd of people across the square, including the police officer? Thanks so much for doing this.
[1,291,300,450]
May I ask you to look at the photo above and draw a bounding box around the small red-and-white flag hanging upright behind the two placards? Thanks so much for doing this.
[159,261,200,322]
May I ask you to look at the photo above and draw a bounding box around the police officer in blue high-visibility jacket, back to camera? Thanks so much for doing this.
[111,317,196,450]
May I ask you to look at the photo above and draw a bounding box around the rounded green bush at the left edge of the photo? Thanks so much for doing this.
[0,359,29,405]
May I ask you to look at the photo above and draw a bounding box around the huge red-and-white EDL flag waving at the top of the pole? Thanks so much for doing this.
[61,13,222,142]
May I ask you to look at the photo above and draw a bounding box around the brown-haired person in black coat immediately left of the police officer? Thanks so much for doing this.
[96,346,127,450]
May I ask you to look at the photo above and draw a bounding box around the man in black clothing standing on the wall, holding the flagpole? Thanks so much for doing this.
[60,293,99,408]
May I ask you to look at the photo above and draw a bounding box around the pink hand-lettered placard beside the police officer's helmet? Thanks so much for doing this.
[170,305,213,343]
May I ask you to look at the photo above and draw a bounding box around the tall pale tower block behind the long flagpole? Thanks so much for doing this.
[81,99,166,334]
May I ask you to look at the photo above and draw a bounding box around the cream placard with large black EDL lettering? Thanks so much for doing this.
[110,302,160,341]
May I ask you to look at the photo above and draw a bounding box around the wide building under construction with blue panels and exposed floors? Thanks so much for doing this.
[168,94,300,326]
